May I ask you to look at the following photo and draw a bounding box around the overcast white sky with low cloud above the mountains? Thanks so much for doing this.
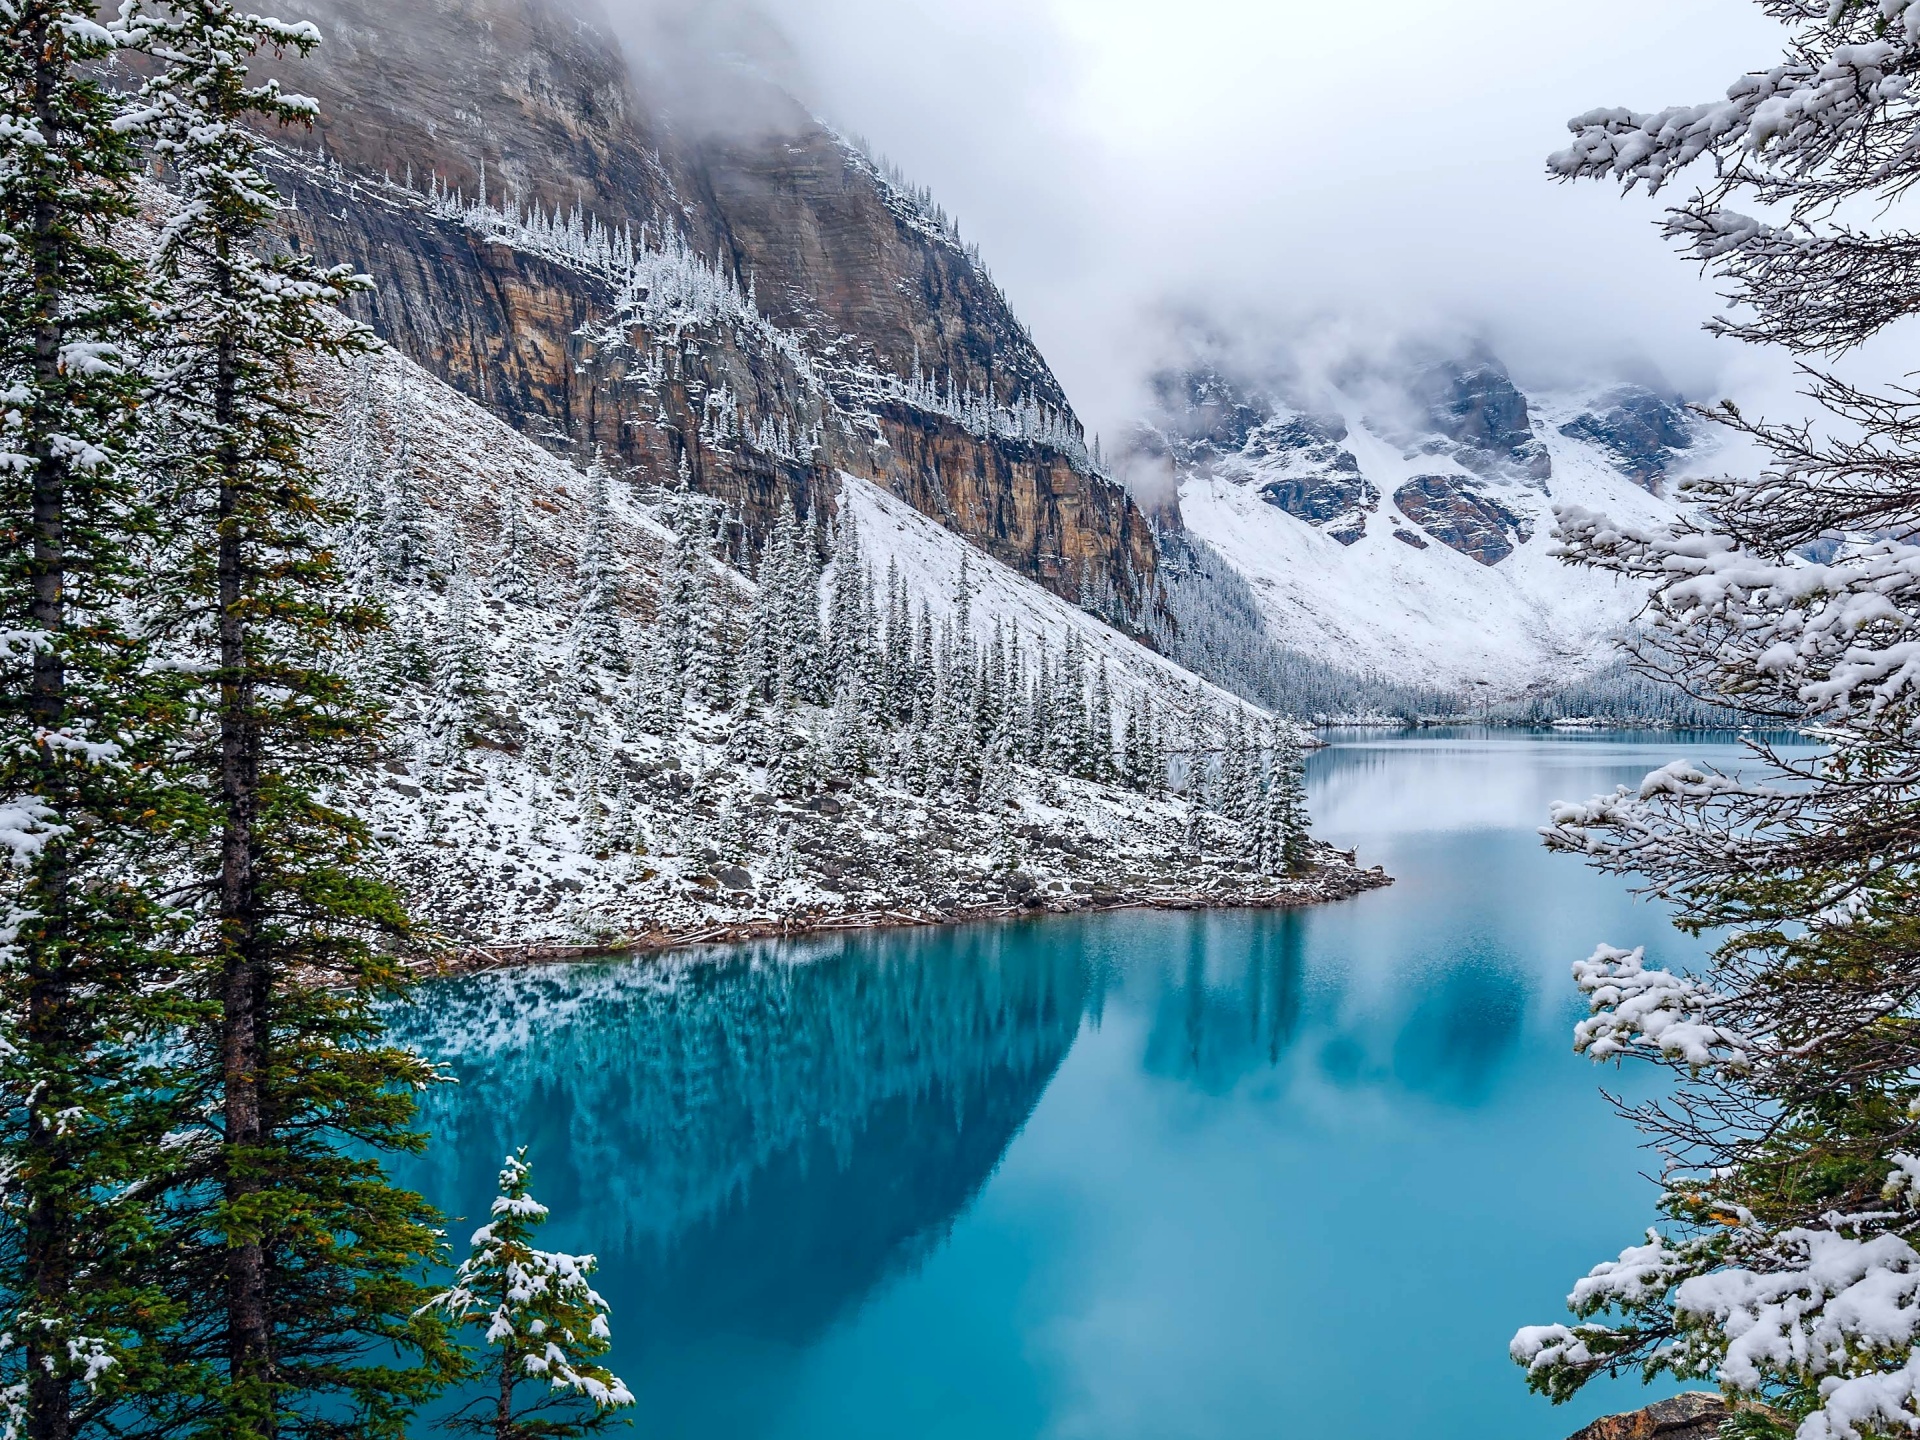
[679,0,1782,428]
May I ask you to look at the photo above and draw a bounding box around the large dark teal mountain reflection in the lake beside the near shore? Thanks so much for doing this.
[387,929,1089,1344]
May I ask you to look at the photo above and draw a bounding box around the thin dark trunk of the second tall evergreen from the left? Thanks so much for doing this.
[213,225,278,1436]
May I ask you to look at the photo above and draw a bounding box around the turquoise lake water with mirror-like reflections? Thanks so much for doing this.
[389,732,1766,1440]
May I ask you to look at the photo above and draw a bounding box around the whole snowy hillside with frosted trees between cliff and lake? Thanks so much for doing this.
[303,351,1384,950]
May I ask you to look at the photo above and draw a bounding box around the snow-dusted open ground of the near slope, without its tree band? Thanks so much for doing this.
[315,339,1384,947]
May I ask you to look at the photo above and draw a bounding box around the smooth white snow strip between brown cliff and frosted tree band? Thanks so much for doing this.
[841,472,1252,710]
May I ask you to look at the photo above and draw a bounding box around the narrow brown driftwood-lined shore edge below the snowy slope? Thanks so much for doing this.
[415,864,1394,975]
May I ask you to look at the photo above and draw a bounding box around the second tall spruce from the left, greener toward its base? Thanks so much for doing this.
[132,0,451,1440]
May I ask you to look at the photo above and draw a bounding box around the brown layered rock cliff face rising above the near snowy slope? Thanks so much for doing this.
[263,0,1156,618]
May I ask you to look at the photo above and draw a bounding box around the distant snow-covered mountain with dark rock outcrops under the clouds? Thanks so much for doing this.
[1127,355,1709,701]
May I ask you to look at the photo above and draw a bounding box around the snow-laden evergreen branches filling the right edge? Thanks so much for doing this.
[1511,11,1920,1440]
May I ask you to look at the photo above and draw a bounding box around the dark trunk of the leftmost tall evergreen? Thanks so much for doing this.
[23,17,75,1440]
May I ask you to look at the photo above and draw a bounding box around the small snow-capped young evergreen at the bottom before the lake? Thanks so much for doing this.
[430,1146,634,1440]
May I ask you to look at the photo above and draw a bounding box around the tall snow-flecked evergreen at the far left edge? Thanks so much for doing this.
[0,0,194,1440]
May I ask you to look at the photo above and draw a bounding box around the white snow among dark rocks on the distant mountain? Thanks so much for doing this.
[1181,397,1697,699]
